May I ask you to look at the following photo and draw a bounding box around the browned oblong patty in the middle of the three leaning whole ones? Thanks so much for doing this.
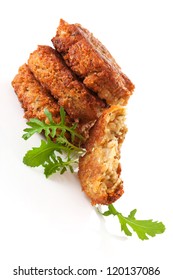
[28,46,105,123]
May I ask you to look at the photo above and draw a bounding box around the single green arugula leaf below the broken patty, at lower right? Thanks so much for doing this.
[98,204,165,240]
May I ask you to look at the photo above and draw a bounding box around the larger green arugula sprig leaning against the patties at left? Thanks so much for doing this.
[22,107,84,177]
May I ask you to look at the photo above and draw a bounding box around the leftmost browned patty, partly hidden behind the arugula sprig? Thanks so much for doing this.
[12,64,60,122]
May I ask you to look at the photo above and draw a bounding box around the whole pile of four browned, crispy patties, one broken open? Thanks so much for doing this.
[12,20,134,204]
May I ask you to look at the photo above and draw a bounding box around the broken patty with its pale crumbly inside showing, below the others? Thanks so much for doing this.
[78,105,127,205]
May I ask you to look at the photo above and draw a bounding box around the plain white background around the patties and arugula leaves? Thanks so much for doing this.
[0,0,173,280]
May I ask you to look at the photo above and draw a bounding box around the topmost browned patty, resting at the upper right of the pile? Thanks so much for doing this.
[52,19,134,105]
